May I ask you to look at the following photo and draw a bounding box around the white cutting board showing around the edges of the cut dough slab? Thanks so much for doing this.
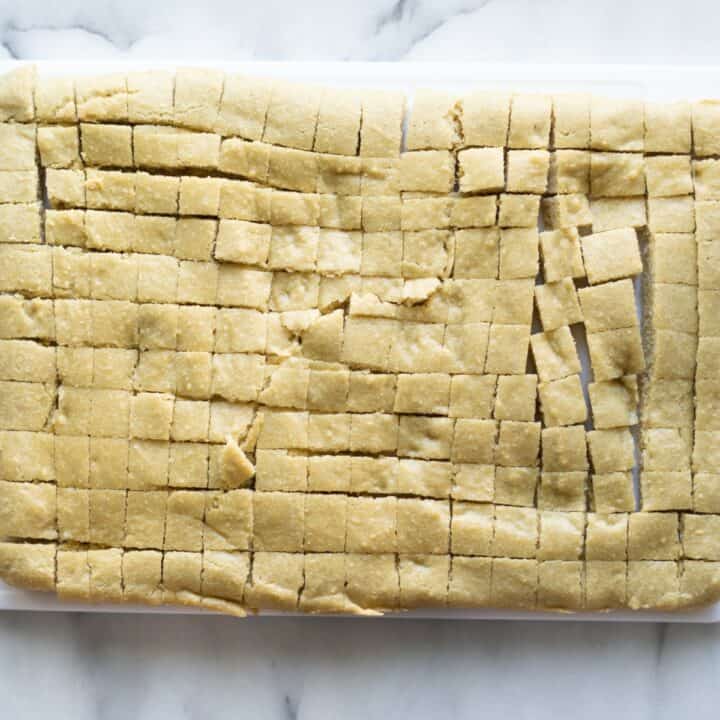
[0,60,720,623]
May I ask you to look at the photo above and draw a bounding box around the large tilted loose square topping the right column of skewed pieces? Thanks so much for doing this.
[581,228,642,285]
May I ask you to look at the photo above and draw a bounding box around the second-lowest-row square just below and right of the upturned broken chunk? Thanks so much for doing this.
[253,491,305,552]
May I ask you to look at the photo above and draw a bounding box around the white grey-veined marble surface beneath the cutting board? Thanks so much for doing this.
[0,0,720,720]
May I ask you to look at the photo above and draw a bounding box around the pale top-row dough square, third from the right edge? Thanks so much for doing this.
[590,96,645,152]
